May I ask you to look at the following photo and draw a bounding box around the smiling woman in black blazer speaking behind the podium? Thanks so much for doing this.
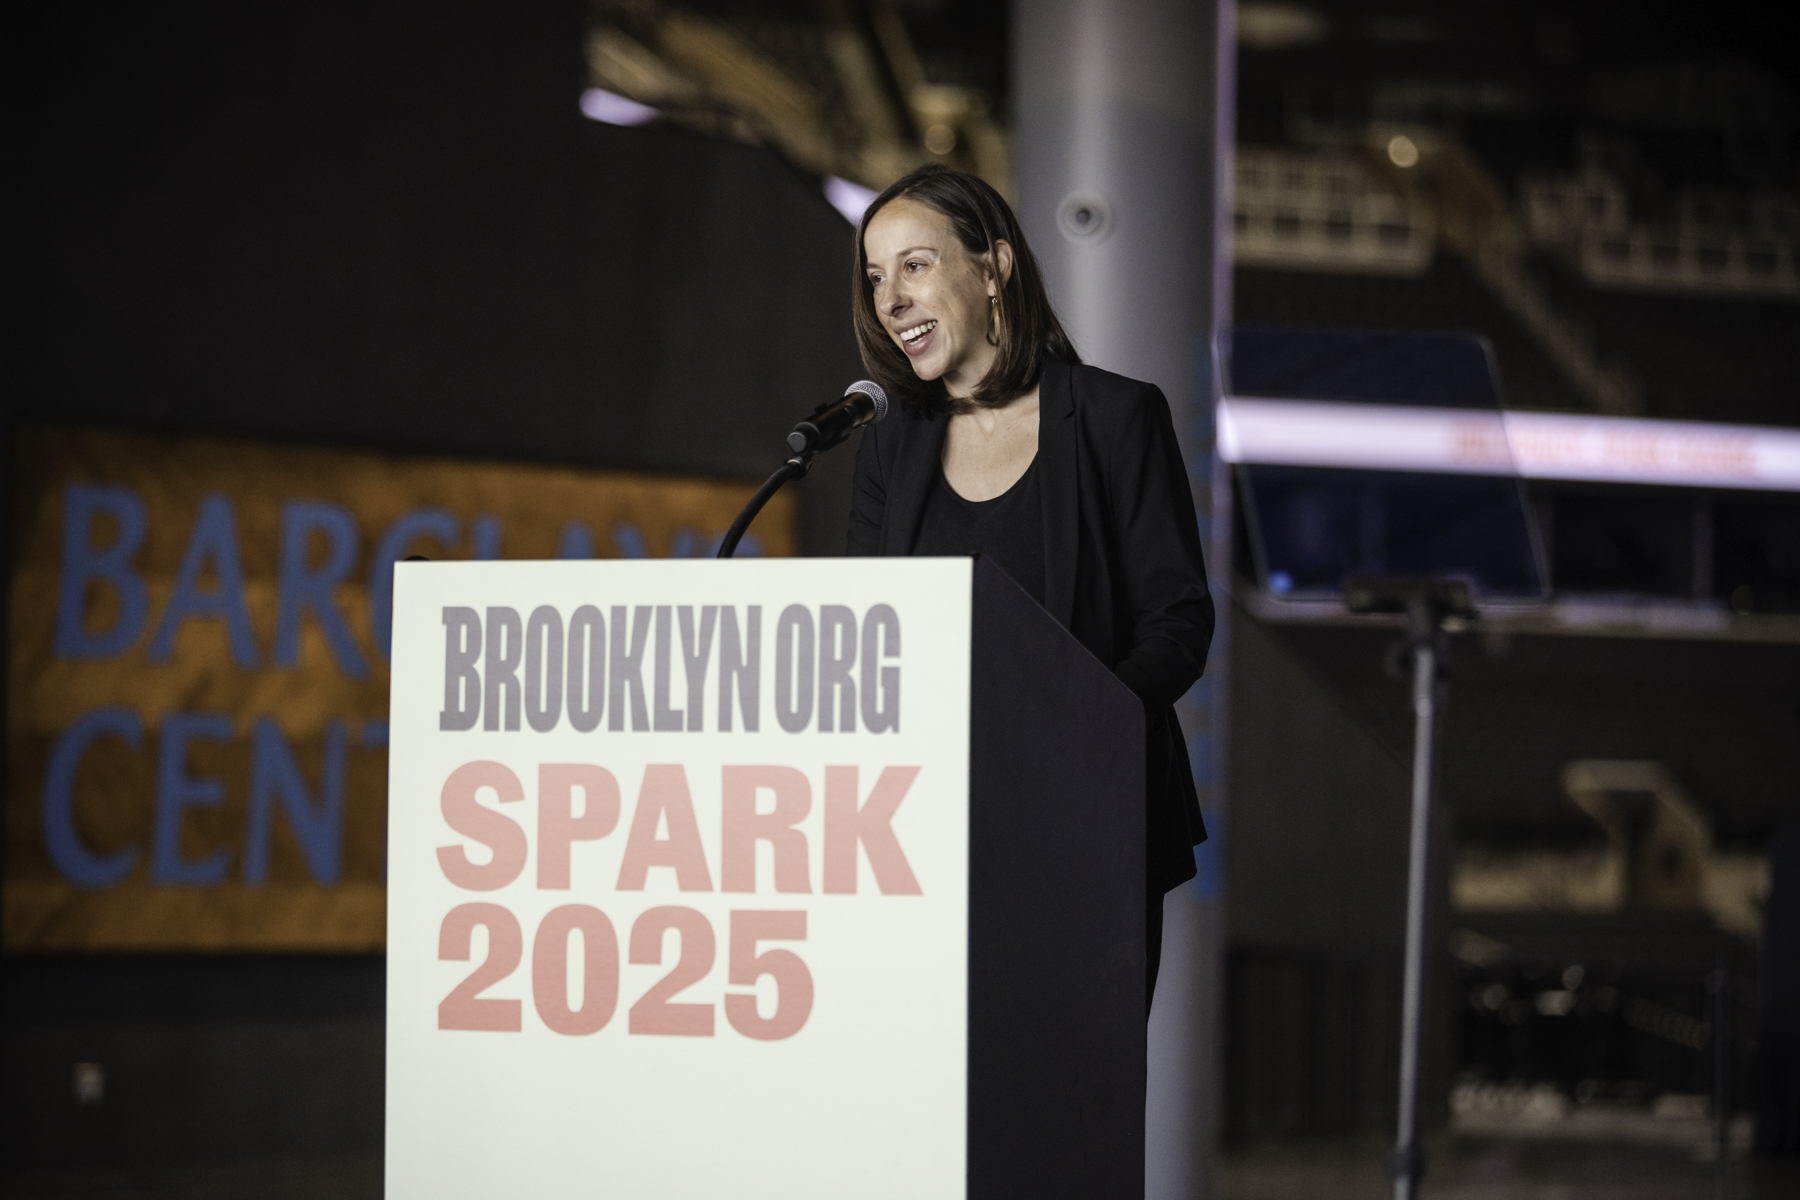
[850,164,1213,1006]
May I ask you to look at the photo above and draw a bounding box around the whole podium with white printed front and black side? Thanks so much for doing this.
[387,558,1145,1200]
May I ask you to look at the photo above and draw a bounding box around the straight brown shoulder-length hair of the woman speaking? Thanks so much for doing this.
[851,162,1082,412]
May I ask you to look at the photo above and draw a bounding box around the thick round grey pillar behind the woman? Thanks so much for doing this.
[1012,0,1237,1200]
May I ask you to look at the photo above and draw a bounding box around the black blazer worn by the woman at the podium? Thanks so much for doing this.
[848,358,1213,894]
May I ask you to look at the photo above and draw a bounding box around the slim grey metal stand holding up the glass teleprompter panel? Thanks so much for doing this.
[1345,576,1474,1200]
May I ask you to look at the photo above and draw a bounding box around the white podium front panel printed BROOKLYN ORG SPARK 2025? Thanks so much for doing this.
[387,560,970,1200]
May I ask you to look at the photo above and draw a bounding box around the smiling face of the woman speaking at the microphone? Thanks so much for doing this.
[862,198,1012,396]
